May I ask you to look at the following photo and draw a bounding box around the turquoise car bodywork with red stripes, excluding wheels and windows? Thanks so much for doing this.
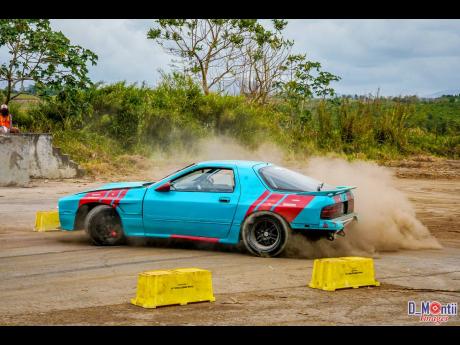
[59,161,356,244]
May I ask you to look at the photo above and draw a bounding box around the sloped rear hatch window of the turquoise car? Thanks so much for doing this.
[259,165,334,192]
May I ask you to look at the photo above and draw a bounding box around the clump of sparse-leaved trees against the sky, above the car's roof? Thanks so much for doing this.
[147,19,340,103]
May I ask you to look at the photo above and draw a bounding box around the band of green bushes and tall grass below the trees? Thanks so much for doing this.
[2,73,460,173]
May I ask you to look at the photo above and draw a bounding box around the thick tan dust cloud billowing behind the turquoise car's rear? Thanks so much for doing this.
[288,157,441,257]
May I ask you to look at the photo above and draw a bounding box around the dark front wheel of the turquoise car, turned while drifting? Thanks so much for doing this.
[85,205,125,246]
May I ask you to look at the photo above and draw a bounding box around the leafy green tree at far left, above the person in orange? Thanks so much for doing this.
[0,19,97,104]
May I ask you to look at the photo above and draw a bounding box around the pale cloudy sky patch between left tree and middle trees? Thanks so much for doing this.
[51,19,170,84]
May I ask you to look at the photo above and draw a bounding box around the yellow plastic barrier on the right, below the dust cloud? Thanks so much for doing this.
[308,256,380,291]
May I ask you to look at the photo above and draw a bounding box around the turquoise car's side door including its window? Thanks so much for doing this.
[143,167,240,238]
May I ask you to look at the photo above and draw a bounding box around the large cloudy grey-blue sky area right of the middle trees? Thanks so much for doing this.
[286,20,460,95]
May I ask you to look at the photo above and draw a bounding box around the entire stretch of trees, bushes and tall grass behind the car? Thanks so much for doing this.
[0,19,460,173]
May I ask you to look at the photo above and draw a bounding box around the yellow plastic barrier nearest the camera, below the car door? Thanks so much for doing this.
[131,268,216,308]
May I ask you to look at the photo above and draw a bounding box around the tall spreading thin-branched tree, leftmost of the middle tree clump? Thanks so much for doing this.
[147,19,260,95]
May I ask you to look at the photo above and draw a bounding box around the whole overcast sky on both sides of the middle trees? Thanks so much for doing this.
[0,19,460,96]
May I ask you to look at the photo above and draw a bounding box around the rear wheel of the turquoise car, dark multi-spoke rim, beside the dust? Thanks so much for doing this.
[241,212,290,257]
